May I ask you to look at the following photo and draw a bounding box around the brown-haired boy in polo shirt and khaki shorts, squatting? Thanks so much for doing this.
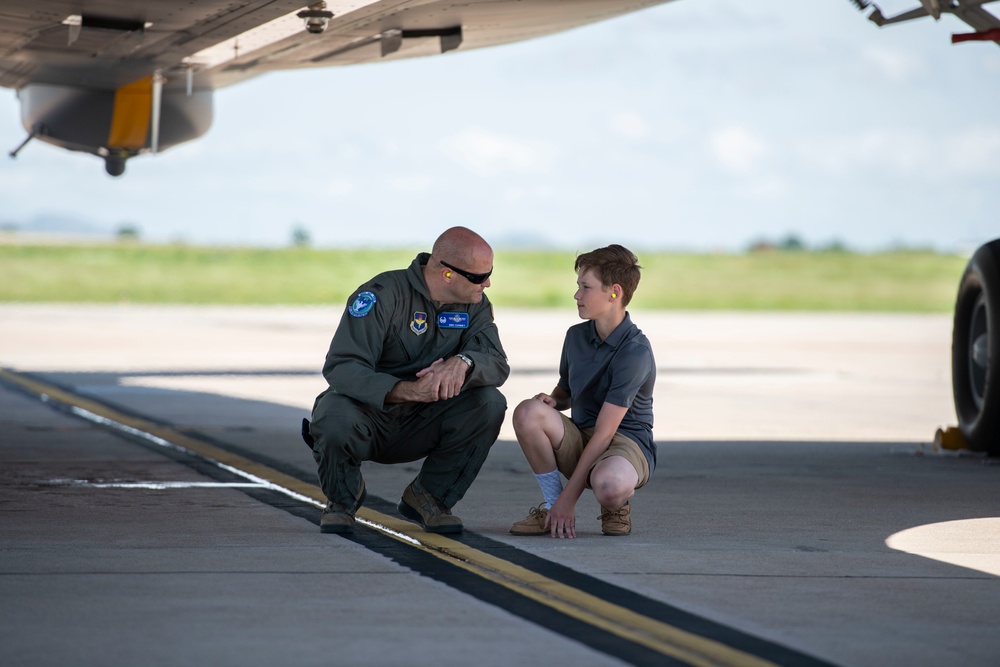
[510,245,656,538]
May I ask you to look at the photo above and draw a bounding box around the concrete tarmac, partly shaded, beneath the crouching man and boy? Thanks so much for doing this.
[0,305,1000,667]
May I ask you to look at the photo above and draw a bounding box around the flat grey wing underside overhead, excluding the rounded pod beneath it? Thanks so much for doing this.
[0,0,663,94]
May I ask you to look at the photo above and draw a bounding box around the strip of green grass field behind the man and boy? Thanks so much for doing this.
[0,243,966,312]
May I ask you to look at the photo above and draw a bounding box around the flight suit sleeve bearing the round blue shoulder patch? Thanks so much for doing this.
[323,286,408,410]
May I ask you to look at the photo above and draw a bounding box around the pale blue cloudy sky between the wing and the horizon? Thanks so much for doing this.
[0,0,1000,252]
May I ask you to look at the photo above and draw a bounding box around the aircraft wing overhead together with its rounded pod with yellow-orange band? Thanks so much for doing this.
[0,0,667,175]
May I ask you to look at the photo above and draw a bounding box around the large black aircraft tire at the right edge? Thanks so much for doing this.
[951,239,1000,456]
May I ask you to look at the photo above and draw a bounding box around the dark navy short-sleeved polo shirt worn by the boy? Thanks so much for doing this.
[559,313,656,472]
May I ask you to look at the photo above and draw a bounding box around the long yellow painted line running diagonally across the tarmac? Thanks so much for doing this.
[0,368,775,667]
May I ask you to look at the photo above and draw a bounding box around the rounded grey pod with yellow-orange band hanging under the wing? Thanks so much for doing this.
[17,77,212,176]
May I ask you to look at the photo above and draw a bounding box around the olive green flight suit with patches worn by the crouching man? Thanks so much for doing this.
[309,253,510,508]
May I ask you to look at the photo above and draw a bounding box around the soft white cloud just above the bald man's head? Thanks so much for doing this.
[443,130,557,175]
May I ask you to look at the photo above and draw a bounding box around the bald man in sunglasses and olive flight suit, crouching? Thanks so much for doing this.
[304,227,510,533]
